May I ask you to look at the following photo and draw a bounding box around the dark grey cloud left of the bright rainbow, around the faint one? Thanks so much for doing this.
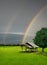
[0,0,47,32]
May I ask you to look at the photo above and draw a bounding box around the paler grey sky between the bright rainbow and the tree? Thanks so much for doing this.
[28,5,47,36]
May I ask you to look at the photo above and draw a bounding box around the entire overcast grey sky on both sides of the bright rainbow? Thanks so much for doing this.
[0,0,47,35]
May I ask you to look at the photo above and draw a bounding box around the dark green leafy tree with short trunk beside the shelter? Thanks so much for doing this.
[33,28,47,52]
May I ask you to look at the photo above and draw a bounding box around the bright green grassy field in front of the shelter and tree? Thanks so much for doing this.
[0,46,47,65]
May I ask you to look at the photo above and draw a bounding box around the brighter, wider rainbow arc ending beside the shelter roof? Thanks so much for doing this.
[22,6,46,43]
